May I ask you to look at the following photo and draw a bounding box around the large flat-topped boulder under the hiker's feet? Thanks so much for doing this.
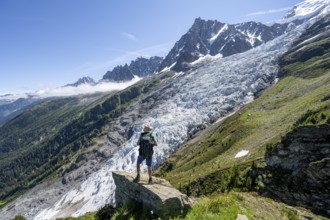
[112,172,194,219]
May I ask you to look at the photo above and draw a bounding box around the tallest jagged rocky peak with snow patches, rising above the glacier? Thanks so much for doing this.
[160,18,300,71]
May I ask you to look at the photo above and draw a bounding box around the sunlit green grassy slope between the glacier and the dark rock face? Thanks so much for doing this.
[157,17,330,198]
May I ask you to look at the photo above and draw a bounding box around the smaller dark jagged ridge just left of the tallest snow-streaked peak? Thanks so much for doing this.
[103,56,163,82]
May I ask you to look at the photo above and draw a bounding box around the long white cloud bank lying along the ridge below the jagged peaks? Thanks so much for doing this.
[31,77,141,98]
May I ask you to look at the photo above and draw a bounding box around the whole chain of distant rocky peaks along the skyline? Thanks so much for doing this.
[0,15,301,121]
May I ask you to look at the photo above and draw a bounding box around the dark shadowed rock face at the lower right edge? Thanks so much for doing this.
[266,125,330,216]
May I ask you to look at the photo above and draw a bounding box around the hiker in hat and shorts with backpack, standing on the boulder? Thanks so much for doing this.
[134,125,158,184]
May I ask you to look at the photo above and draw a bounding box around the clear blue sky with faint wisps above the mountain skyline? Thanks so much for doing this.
[0,0,302,95]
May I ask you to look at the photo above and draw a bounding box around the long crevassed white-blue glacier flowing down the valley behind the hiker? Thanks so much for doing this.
[33,19,314,220]
